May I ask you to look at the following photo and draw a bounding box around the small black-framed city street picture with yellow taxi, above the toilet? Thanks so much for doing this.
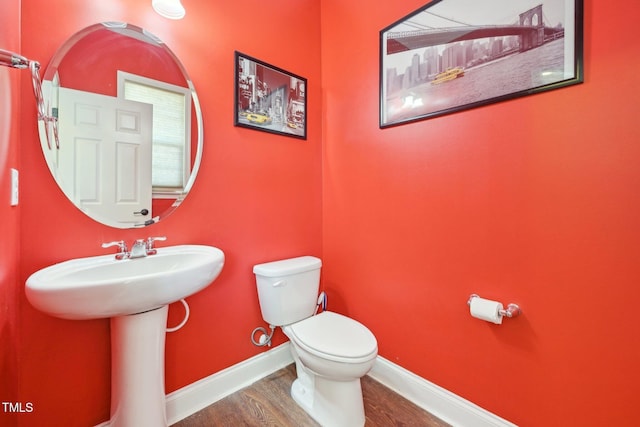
[234,51,307,139]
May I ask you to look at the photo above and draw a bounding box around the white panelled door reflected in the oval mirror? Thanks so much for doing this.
[58,88,153,225]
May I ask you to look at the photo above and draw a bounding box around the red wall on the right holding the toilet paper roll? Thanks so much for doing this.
[321,0,640,426]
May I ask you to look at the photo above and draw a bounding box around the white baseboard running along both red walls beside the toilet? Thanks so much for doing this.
[98,342,517,427]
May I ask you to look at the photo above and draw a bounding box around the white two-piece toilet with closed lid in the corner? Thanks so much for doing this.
[253,256,378,427]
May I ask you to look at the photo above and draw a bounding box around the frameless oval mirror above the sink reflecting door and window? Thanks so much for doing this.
[39,22,203,228]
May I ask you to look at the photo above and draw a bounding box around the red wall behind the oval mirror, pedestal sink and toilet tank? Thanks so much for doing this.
[15,0,322,427]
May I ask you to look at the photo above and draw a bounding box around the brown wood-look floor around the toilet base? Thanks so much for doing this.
[172,364,450,427]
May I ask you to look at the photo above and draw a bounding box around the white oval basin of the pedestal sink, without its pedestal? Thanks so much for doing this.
[26,245,224,320]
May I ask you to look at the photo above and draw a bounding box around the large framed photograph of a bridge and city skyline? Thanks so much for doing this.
[380,0,583,128]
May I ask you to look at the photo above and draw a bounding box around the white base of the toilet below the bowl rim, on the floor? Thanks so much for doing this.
[291,364,365,427]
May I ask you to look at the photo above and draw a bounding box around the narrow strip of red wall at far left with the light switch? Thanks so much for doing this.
[0,0,22,425]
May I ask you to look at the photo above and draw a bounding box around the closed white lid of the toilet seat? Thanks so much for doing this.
[288,311,378,358]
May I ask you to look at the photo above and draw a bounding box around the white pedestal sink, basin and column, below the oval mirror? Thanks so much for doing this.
[26,245,224,427]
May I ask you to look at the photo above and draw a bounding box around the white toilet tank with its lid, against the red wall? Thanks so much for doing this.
[253,256,322,326]
